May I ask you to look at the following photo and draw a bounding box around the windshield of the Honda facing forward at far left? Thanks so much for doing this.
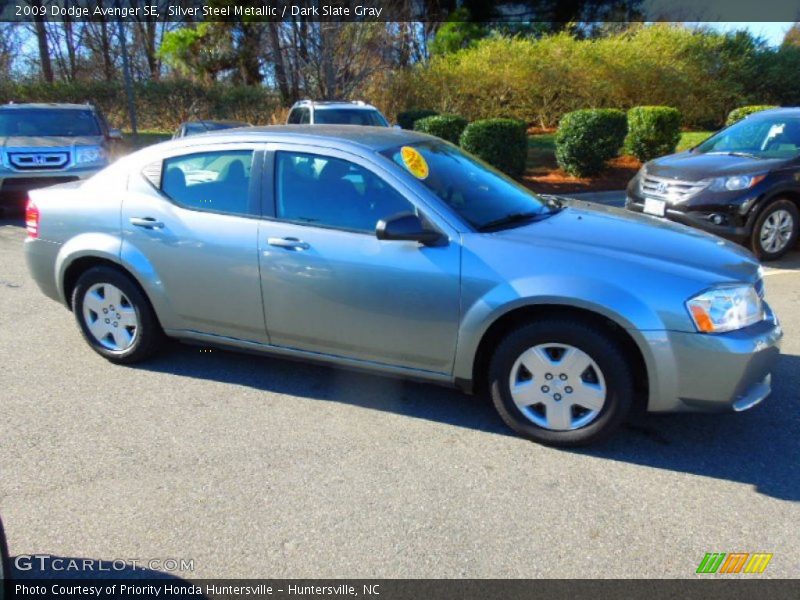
[0,108,102,137]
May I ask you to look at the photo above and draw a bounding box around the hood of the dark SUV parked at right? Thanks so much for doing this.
[646,151,786,181]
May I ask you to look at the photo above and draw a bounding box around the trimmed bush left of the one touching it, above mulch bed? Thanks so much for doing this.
[556,108,628,177]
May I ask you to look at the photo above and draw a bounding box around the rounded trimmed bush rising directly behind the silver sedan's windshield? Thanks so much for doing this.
[459,119,528,175]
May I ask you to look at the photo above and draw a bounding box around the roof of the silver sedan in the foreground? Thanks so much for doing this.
[158,125,438,151]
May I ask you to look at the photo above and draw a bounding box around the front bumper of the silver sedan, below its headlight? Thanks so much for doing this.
[644,307,783,412]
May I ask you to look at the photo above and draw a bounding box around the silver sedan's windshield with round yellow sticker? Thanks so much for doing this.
[381,141,554,230]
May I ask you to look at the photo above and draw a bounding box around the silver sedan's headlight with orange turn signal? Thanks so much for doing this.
[686,285,764,333]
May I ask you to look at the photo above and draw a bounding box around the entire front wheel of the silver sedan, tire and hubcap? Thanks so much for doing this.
[489,320,633,447]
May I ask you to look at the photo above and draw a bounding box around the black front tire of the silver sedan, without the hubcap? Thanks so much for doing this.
[488,319,634,447]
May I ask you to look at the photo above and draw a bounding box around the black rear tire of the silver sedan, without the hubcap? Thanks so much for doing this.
[72,266,164,364]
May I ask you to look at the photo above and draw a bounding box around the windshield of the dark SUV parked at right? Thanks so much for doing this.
[693,115,800,158]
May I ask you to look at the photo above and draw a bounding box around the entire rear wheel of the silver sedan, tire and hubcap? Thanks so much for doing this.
[72,267,163,364]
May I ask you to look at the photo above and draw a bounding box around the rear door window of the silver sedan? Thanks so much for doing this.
[161,150,253,215]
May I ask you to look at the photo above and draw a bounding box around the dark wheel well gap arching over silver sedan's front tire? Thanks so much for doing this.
[472,304,648,409]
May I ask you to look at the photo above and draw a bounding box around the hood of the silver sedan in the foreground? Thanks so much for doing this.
[495,200,760,284]
